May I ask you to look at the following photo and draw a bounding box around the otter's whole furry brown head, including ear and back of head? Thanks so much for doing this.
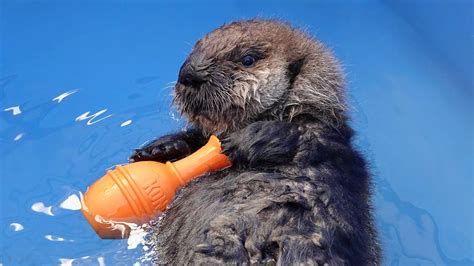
[174,20,345,134]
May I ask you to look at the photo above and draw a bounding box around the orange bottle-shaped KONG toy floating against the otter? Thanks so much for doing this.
[81,136,231,238]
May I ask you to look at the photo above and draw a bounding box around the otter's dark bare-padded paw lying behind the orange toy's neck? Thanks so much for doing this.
[129,130,205,162]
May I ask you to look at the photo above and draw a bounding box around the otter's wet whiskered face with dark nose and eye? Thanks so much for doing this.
[174,21,291,134]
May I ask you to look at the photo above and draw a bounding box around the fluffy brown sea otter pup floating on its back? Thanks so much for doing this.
[131,20,380,265]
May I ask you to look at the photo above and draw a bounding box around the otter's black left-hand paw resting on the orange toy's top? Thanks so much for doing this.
[129,135,192,162]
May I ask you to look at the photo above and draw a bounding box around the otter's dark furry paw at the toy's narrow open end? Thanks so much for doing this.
[222,121,300,168]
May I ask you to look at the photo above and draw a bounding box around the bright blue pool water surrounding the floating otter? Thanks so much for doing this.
[0,0,474,265]
